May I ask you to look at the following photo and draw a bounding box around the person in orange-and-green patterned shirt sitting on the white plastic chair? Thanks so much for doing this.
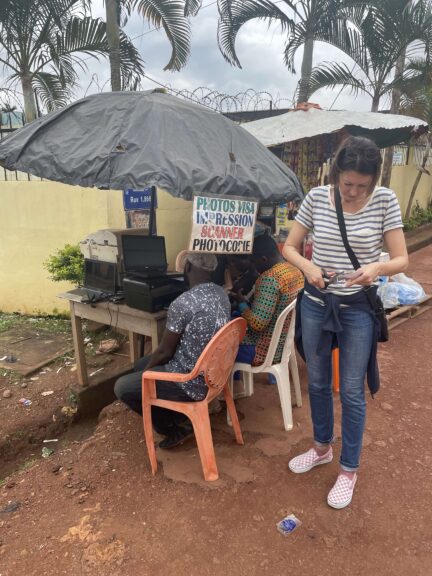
[234,234,303,376]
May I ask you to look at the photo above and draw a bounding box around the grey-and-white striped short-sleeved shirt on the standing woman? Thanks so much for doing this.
[296,186,403,294]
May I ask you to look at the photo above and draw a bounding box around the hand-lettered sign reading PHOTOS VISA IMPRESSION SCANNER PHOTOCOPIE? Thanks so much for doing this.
[189,196,258,254]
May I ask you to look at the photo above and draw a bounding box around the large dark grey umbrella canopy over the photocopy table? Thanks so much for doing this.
[0,90,303,200]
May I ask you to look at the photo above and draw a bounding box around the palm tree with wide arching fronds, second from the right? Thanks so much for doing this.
[186,0,358,102]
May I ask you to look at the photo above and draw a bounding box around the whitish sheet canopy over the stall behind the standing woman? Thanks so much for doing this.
[243,108,428,148]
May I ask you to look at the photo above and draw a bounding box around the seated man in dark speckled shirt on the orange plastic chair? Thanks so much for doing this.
[114,251,230,448]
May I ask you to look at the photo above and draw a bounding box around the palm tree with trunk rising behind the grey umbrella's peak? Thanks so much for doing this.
[105,0,190,90]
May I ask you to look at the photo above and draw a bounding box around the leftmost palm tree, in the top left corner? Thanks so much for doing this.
[0,0,144,122]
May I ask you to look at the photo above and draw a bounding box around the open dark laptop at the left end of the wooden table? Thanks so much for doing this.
[58,259,117,303]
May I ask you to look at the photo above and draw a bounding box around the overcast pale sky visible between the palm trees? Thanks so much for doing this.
[82,0,371,110]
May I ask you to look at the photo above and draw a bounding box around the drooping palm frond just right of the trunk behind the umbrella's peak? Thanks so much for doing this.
[131,0,191,71]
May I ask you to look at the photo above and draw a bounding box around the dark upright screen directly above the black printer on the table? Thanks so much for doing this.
[121,234,168,276]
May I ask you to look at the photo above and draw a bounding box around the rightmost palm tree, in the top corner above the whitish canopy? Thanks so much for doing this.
[311,0,432,112]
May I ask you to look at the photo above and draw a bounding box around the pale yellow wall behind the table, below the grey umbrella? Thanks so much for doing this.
[0,180,191,314]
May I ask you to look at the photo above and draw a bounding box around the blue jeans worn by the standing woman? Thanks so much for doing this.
[301,294,374,471]
